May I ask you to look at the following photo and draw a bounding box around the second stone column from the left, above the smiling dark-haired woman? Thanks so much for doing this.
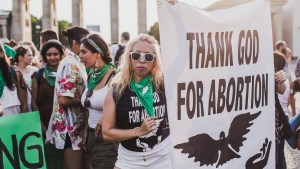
[42,0,58,33]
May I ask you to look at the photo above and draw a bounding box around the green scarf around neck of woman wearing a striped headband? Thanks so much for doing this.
[88,64,110,90]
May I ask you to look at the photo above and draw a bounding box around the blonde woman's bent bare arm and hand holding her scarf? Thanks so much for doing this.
[100,88,156,141]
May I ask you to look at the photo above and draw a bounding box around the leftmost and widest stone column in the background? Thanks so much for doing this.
[11,0,32,41]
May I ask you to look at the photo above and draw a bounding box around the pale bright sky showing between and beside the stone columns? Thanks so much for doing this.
[0,0,218,42]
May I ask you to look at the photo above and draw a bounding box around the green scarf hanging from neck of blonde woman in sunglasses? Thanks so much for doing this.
[130,75,154,117]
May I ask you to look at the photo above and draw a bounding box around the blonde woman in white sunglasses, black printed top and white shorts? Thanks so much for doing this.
[101,34,173,169]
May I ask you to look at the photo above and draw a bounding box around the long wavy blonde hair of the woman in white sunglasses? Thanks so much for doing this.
[113,34,163,95]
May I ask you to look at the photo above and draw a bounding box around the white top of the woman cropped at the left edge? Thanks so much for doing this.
[0,86,21,109]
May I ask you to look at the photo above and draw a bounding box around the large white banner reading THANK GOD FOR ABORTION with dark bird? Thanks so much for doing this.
[158,0,275,169]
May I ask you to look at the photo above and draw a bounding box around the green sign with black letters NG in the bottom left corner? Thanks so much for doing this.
[0,112,46,169]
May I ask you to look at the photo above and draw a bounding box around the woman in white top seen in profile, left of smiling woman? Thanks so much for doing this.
[13,45,38,112]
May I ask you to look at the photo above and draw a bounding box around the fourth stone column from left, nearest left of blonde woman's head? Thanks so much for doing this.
[110,0,119,43]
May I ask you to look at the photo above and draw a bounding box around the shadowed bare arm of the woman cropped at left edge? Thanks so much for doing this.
[16,71,28,113]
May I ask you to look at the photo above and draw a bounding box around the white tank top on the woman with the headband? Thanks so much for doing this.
[81,85,109,128]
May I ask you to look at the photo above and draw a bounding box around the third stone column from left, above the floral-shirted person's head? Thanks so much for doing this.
[72,0,83,26]
